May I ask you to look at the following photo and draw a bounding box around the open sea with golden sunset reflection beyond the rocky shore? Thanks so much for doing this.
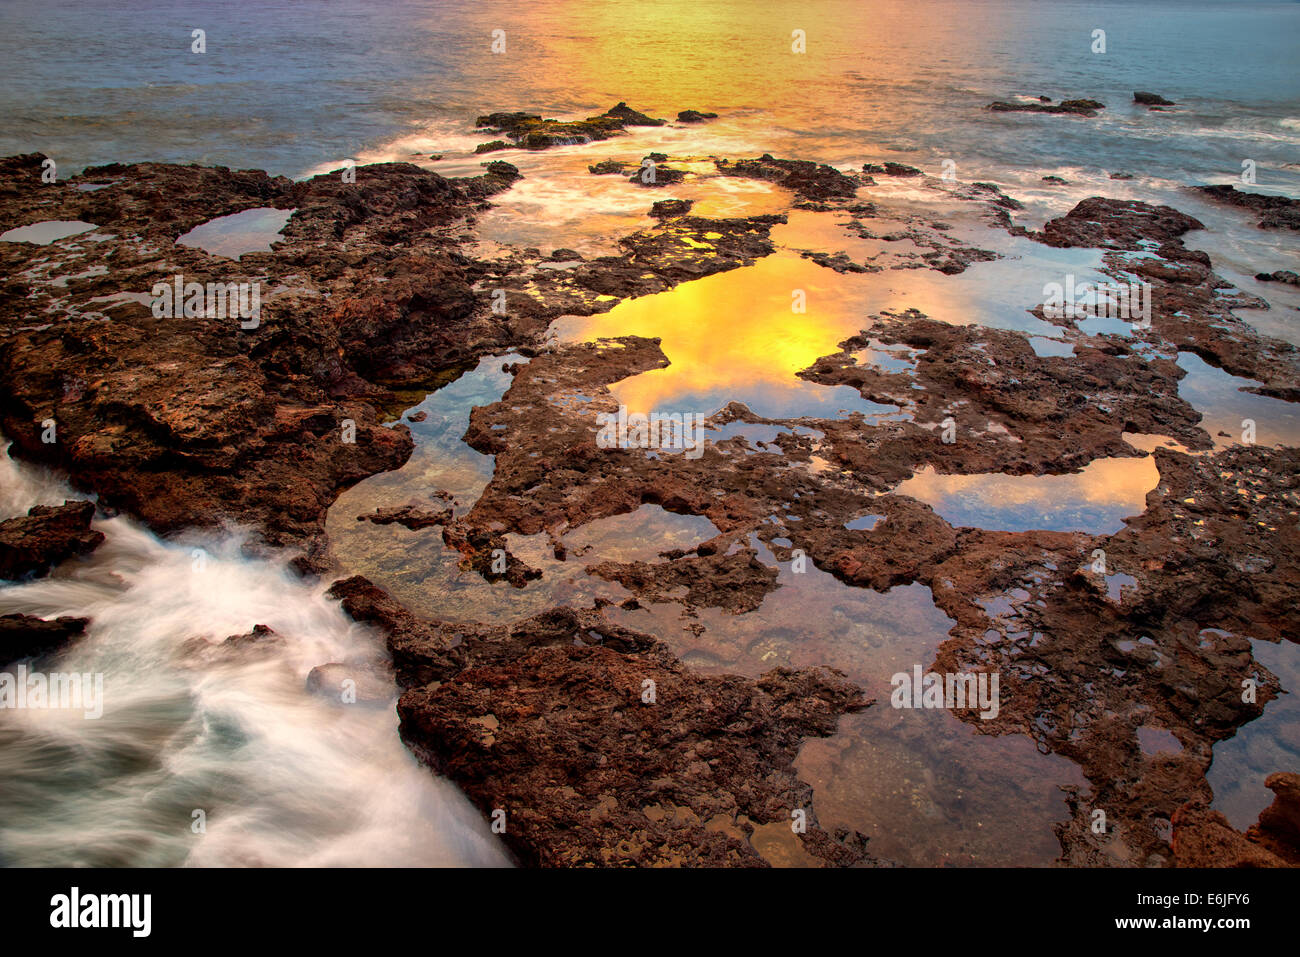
[0,0,1300,194]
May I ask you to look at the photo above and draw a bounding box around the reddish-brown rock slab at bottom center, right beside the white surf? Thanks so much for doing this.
[332,579,870,866]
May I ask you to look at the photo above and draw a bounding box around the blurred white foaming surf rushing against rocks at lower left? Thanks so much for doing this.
[0,444,506,866]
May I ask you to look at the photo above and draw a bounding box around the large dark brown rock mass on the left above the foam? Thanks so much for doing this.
[0,130,783,571]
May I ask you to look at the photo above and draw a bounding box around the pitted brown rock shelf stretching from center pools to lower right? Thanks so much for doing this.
[439,202,1300,866]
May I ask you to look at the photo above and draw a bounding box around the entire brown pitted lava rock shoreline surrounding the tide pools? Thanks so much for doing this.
[0,110,1300,866]
